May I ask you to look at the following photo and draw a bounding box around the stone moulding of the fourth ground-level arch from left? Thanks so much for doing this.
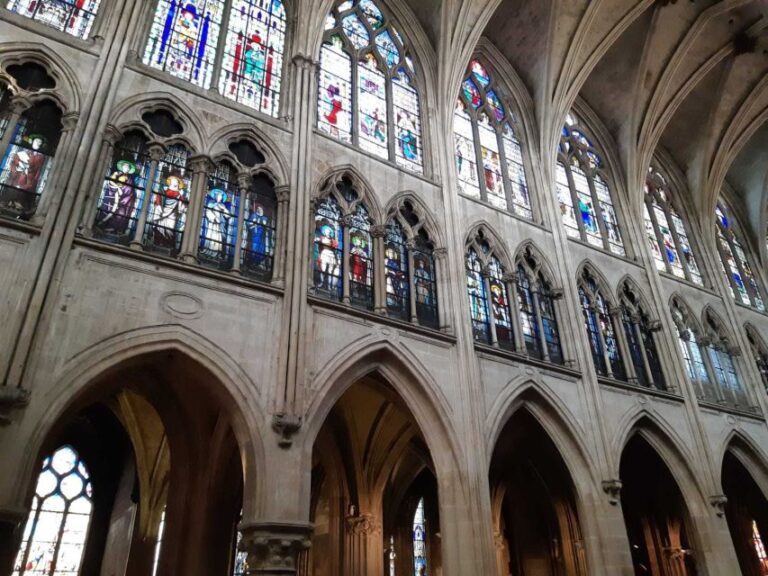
[612,408,707,512]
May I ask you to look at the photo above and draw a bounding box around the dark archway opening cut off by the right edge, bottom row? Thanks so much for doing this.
[722,450,768,576]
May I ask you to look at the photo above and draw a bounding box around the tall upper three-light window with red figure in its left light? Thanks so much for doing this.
[317,0,424,173]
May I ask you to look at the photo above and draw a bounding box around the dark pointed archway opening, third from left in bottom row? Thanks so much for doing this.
[490,410,587,576]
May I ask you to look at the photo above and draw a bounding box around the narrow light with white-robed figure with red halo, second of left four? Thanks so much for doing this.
[144,144,191,256]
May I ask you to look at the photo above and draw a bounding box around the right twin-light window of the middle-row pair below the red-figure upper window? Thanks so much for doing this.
[384,200,439,328]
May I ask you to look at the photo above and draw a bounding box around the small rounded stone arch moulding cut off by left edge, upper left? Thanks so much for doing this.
[0,42,82,113]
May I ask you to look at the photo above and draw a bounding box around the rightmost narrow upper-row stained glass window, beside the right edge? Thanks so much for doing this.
[715,203,765,311]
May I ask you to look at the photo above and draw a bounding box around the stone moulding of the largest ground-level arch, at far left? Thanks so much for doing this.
[14,325,266,517]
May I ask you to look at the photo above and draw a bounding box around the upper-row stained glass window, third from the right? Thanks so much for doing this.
[556,114,626,256]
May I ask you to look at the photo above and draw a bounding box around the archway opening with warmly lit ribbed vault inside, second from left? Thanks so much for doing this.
[300,373,441,576]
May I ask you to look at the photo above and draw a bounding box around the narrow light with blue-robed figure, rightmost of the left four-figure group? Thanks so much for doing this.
[240,175,277,280]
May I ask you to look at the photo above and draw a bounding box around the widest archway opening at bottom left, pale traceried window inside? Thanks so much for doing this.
[14,351,243,576]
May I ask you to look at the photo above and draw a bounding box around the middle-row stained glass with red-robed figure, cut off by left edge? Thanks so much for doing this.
[0,101,62,220]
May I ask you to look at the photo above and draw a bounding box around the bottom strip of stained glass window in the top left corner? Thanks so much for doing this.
[5,0,101,39]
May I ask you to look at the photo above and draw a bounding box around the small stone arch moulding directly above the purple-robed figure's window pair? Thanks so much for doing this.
[109,92,207,153]
